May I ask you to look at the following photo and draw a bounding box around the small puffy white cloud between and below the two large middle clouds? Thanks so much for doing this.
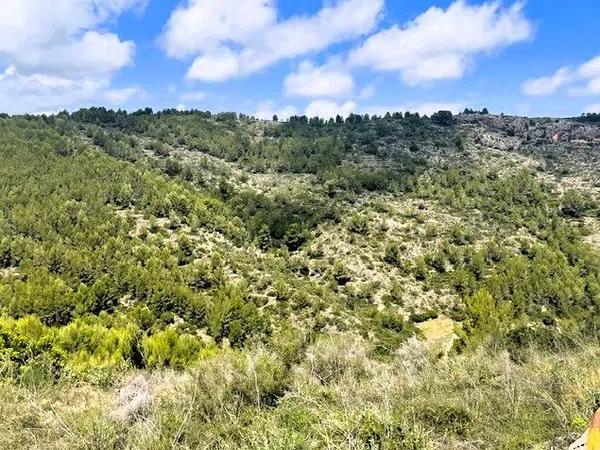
[284,61,354,97]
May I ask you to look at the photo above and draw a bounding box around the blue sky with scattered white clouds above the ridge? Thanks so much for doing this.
[0,0,600,119]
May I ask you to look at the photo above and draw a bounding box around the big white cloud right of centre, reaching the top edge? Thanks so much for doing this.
[350,0,533,85]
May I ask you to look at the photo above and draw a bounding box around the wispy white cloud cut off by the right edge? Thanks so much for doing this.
[521,56,600,96]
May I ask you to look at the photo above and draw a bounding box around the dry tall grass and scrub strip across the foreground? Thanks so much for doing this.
[0,334,600,450]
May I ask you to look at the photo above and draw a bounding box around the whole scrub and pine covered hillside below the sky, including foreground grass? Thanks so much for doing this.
[0,108,600,449]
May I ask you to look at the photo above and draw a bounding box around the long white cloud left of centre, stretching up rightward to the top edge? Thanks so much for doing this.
[161,0,384,81]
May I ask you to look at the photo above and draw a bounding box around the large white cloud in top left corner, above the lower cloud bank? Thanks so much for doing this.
[0,0,141,75]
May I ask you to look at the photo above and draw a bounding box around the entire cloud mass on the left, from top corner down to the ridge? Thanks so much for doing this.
[0,0,147,112]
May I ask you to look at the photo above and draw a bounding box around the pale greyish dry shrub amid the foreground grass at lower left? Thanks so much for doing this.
[111,375,152,424]
